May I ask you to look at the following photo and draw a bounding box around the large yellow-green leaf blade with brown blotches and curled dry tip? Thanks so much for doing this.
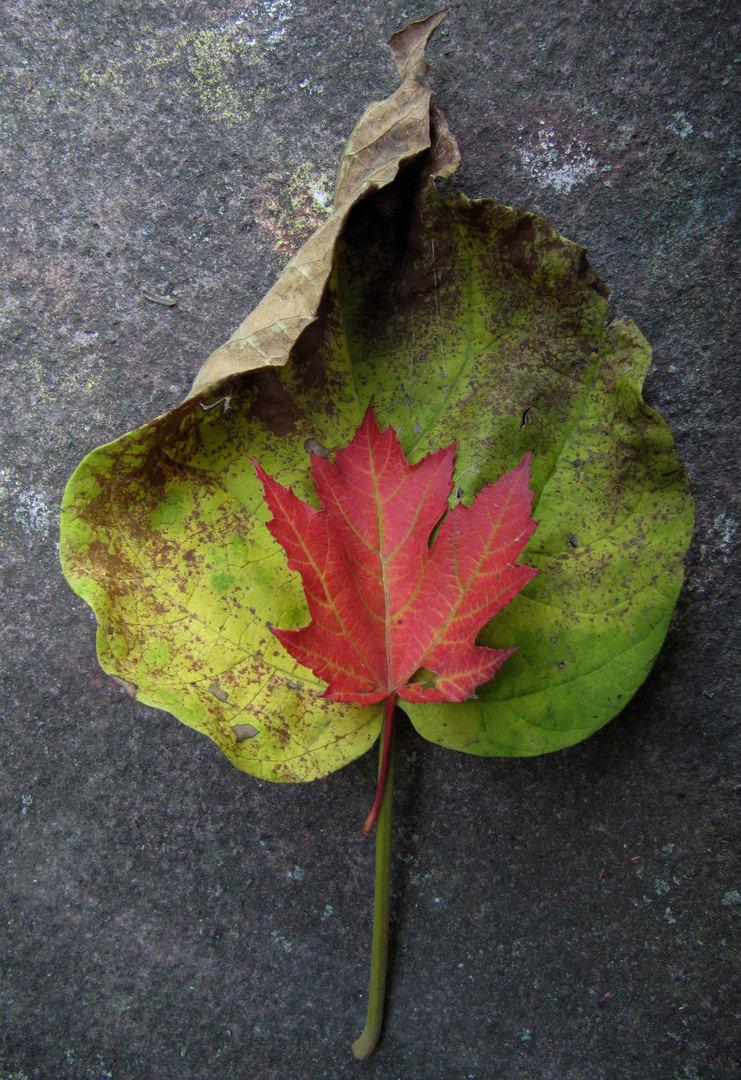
[60,25,693,781]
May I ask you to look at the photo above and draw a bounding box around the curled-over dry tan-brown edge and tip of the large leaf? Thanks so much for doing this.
[188,10,459,399]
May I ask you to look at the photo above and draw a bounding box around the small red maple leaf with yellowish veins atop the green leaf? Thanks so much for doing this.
[254,408,538,820]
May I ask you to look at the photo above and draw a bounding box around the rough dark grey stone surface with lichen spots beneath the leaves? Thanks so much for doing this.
[0,0,741,1080]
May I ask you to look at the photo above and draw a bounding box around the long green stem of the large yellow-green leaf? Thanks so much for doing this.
[352,693,396,1059]
